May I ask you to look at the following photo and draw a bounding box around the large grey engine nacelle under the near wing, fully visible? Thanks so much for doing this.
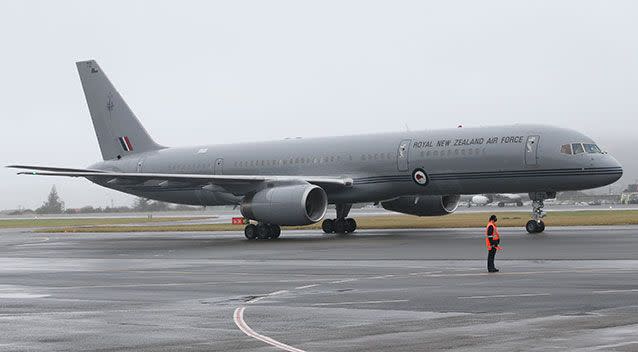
[240,184,328,226]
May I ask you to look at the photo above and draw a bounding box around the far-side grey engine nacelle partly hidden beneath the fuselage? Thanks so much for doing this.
[381,194,461,216]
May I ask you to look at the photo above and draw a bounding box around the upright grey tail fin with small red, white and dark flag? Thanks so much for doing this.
[76,60,164,160]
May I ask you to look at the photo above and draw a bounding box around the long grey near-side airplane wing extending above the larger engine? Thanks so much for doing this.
[7,165,353,195]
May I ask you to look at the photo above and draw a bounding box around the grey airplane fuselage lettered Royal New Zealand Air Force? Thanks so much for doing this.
[90,125,622,205]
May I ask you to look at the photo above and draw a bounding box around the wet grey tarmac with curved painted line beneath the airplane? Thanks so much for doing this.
[0,226,638,352]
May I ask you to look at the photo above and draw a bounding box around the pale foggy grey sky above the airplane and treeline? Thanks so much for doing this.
[0,0,638,209]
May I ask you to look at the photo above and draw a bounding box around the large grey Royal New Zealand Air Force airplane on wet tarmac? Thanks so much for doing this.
[10,60,623,239]
